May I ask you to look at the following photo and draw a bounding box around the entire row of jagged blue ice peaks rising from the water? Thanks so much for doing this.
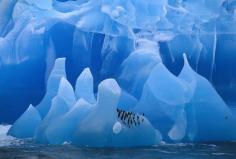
[8,57,236,147]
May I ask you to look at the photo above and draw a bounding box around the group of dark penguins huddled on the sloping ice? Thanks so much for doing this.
[116,109,144,128]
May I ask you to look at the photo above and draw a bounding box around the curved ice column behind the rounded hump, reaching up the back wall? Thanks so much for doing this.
[118,39,161,98]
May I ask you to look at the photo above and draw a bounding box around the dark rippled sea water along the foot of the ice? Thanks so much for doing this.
[0,125,236,159]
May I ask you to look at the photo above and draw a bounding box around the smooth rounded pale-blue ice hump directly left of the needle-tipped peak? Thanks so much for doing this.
[134,63,189,140]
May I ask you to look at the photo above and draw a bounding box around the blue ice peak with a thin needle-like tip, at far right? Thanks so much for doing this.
[179,56,236,142]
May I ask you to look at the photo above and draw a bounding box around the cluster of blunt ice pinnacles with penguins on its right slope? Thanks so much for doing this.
[8,65,162,147]
